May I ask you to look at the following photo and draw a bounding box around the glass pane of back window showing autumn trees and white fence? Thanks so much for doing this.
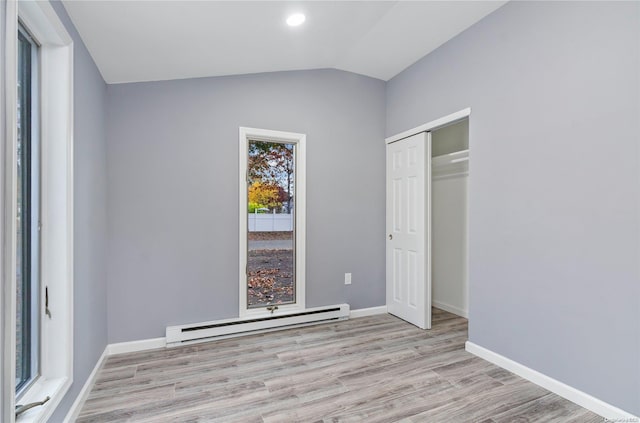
[247,141,296,308]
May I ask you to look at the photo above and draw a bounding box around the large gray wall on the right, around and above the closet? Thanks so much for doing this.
[386,2,640,415]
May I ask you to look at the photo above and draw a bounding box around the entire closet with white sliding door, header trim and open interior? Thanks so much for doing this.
[385,108,471,332]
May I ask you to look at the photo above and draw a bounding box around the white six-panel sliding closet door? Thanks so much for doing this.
[386,132,431,329]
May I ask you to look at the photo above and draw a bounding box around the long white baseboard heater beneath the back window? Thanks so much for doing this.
[167,304,349,347]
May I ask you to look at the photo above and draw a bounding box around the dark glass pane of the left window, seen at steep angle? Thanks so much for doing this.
[16,20,40,394]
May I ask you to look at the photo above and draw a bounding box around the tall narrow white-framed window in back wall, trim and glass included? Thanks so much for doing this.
[239,128,306,317]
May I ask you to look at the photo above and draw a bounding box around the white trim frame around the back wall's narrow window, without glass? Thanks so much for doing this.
[239,127,307,318]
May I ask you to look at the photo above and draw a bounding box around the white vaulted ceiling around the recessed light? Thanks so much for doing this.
[63,0,506,83]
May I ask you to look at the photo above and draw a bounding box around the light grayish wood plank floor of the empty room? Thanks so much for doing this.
[77,309,603,423]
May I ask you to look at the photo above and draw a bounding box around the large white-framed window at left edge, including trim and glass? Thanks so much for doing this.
[2,1,73,423]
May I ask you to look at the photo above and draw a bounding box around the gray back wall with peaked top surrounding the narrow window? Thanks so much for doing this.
[107,70,385,342]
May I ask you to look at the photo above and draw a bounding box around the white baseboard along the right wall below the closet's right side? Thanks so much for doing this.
[465,341,640,422]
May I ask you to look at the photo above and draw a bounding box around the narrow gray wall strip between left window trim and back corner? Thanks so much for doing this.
[50,1,107,422]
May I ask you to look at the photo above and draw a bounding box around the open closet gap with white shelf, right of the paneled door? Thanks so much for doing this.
[431,118,469,328]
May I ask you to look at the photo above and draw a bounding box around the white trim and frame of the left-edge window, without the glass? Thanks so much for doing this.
[8,0,73,423]
